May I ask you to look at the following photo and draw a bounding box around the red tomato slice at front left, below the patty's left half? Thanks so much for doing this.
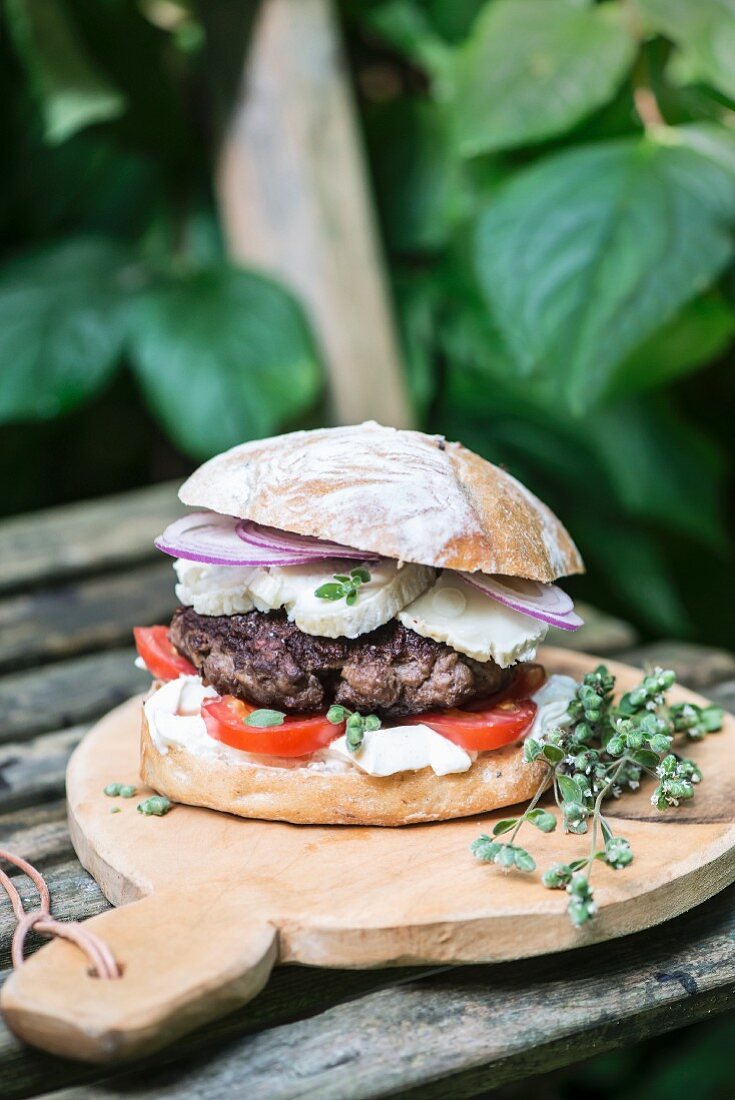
[201,695,344,757]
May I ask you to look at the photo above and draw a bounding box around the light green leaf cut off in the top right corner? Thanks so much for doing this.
[634,0,735,99]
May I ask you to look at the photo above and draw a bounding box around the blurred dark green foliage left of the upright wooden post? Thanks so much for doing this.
[0,0,322,468]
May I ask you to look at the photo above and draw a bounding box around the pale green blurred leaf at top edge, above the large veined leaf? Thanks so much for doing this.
[452,0,635,156]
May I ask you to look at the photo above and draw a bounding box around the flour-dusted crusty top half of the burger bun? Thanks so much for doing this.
[179,421,584,583]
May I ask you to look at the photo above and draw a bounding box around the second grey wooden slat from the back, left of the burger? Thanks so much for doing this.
[0,556,176,671]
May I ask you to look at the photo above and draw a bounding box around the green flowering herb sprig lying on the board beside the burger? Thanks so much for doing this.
[471,664,724,927]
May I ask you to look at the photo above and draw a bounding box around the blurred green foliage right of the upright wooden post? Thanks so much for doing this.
[343,0,735,645]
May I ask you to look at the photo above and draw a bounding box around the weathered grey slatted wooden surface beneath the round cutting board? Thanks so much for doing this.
[0,485,735,1100]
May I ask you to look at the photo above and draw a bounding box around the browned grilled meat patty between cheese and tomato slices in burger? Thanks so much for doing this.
[169,607,511,718]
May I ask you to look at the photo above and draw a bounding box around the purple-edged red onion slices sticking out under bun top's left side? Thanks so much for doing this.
[155,512,376,567]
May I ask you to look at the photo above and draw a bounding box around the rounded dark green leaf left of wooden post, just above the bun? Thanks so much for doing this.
[132,264,321,457]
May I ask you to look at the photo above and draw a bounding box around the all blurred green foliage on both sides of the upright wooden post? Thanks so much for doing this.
[0,0,735,645]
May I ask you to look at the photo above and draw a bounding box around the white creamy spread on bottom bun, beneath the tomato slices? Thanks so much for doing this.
[143,675,577,776]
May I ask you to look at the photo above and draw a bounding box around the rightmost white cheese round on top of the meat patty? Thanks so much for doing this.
[397,570,548,669]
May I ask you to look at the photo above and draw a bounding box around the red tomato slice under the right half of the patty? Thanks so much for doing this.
[404,699,537,752]
